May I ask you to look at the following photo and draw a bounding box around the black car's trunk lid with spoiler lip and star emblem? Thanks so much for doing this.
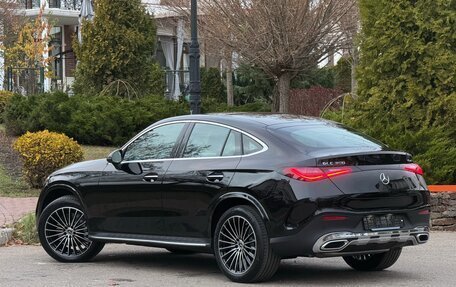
[316,150,429,211]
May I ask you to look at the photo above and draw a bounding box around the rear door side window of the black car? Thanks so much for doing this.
[183,123,230,158]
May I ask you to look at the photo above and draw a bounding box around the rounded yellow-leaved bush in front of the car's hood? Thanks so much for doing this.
[13,130,83,187]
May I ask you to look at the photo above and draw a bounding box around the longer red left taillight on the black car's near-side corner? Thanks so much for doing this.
[283,167,352,182]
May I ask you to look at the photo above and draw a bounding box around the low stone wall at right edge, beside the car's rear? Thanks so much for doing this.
[431,192,456,231]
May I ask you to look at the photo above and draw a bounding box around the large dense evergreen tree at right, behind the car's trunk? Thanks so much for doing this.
[336,0,456,183]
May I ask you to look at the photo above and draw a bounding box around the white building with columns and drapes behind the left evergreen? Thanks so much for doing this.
[0,0,219,98]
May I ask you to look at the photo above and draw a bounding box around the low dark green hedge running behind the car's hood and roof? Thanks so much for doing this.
[5,92,270,146]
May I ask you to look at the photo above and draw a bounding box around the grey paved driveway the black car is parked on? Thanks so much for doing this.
[0,232,456,287]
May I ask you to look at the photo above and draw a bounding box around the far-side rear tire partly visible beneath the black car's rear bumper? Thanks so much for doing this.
[343,248,402,271]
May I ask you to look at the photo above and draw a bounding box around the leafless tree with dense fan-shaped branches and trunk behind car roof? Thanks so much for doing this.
[167,0,356,112]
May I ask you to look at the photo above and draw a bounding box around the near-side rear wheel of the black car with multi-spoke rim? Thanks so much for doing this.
[213,205,280,283]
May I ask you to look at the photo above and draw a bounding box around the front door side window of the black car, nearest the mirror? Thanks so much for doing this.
[124,123,185,161]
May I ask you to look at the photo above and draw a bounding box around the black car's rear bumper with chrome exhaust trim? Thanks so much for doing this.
[270,207,430,258]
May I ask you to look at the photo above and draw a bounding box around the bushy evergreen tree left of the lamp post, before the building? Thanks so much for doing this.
[73,0,156,96]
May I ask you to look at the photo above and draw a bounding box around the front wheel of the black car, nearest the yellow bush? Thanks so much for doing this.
[38,196,104,262]
